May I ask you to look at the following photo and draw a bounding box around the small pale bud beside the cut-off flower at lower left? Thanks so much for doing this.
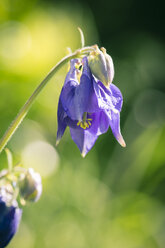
[19,168,42,202]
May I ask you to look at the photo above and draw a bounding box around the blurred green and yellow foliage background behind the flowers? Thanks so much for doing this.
[0,0,165,248]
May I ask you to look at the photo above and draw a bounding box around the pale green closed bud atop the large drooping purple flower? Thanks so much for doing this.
[88,45,114,87]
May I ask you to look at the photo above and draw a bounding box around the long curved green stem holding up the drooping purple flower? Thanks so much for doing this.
[0,47,91,152]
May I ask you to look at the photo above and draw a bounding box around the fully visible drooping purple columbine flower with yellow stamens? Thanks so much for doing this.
[57,57,125,157]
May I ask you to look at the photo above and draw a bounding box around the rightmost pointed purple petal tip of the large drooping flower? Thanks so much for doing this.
[109,111,126,147]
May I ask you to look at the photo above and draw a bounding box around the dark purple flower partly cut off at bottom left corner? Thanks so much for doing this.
[0,196,22,248]
